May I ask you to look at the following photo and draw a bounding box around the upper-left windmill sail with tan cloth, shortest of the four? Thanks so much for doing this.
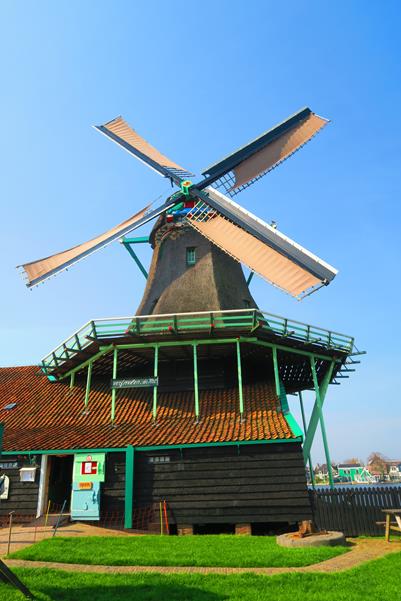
[94,117,193,185]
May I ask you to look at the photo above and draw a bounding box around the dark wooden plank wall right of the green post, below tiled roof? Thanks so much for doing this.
[134,443,311,524]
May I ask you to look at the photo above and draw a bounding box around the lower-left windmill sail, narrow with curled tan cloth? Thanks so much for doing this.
[18,203,174,288]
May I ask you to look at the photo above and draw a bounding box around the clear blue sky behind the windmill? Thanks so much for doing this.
[0,0,401,460]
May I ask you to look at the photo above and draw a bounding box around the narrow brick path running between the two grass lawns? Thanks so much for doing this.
[6,539,401,576]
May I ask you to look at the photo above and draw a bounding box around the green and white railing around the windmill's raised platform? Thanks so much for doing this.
[41,309,354,373]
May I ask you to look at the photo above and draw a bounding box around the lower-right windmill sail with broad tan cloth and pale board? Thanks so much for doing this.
[187,188,337,298]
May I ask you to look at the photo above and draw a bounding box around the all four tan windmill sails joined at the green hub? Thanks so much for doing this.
[21,108,337,298]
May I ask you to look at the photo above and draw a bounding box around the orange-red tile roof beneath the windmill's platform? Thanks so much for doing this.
[0,366,294,451]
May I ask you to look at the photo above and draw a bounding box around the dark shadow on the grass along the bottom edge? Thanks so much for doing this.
[37,582,228,601]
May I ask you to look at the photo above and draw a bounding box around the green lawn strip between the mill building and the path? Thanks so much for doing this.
[10,535,347,568]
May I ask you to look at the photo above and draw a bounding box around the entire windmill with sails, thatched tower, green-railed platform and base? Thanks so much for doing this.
[6,108,360,532]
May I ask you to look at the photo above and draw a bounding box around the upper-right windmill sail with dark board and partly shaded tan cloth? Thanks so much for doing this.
[198,108,328,196]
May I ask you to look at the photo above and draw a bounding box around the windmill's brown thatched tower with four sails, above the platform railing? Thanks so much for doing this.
[20,108,337,314]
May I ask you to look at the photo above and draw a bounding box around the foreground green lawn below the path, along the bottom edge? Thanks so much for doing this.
[0,553,401,601]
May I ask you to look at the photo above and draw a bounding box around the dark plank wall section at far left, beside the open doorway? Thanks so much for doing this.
[0,455,41,522]
